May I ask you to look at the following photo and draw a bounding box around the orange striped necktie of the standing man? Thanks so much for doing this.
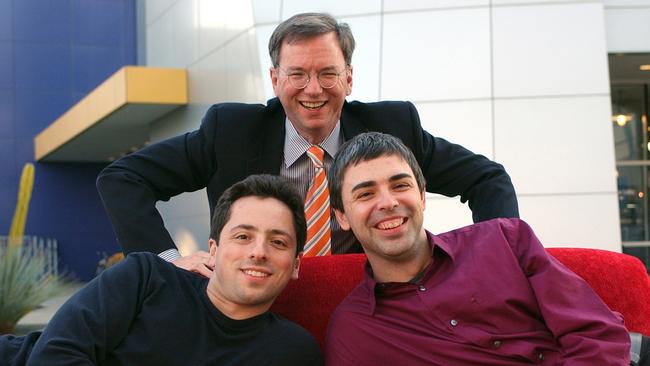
[304,145,332,257]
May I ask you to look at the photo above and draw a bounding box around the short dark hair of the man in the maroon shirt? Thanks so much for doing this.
[327,132,426,212]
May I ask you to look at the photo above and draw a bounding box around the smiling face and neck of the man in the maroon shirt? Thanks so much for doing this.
[335,155,429,274]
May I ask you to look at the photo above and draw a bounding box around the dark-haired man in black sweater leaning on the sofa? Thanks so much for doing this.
[0,175,322,365]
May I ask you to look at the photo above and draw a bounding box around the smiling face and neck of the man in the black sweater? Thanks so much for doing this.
[207,196,300,319]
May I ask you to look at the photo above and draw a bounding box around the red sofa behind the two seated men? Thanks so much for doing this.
[271,248,650,346]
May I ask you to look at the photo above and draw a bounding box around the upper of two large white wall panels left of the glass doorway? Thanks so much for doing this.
[492,3,609,97]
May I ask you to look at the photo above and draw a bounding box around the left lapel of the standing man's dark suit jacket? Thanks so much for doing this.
[246,98,286,175]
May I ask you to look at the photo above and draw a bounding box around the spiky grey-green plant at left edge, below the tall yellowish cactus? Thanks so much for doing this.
[0,245,70,334]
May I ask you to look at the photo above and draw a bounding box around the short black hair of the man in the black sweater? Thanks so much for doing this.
[210,174,307,255]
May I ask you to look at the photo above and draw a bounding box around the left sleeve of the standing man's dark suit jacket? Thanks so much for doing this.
[97,106,219,254]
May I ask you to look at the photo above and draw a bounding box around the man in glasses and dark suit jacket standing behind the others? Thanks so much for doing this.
[97,13,518,276]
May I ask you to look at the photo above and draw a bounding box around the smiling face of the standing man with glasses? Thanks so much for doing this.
[270,32,352,144]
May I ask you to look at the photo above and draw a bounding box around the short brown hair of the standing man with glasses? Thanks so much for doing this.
[269,13,355,67]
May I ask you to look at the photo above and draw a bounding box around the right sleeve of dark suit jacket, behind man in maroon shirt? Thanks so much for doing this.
[407,103,519,222]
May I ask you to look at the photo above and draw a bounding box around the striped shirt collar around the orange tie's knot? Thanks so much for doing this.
[284,118,343,168]
